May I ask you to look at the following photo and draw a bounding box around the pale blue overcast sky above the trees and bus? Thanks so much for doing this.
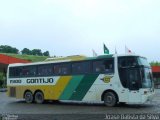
[0,0,160,61]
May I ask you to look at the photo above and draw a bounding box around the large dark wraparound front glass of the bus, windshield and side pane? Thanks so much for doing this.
[118,56,152,90]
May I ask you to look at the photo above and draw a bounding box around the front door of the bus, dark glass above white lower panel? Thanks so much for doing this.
[127,68,141,103]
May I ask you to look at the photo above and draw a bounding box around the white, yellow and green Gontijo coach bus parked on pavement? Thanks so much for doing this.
[7,54,154,106]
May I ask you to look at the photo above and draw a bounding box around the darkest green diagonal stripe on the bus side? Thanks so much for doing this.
[70,74,98,101]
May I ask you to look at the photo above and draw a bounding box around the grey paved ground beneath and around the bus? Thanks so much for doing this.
[0,90,160,120]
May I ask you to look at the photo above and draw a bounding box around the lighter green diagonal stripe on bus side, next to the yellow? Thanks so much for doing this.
[59,75,84,100]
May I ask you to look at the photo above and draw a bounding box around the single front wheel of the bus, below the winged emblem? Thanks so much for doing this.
[104,92,117,107]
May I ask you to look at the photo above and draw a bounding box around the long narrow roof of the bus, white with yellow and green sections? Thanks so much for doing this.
[9,54,142,67]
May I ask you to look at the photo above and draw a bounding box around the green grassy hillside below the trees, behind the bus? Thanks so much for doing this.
[1,53,48,62]
